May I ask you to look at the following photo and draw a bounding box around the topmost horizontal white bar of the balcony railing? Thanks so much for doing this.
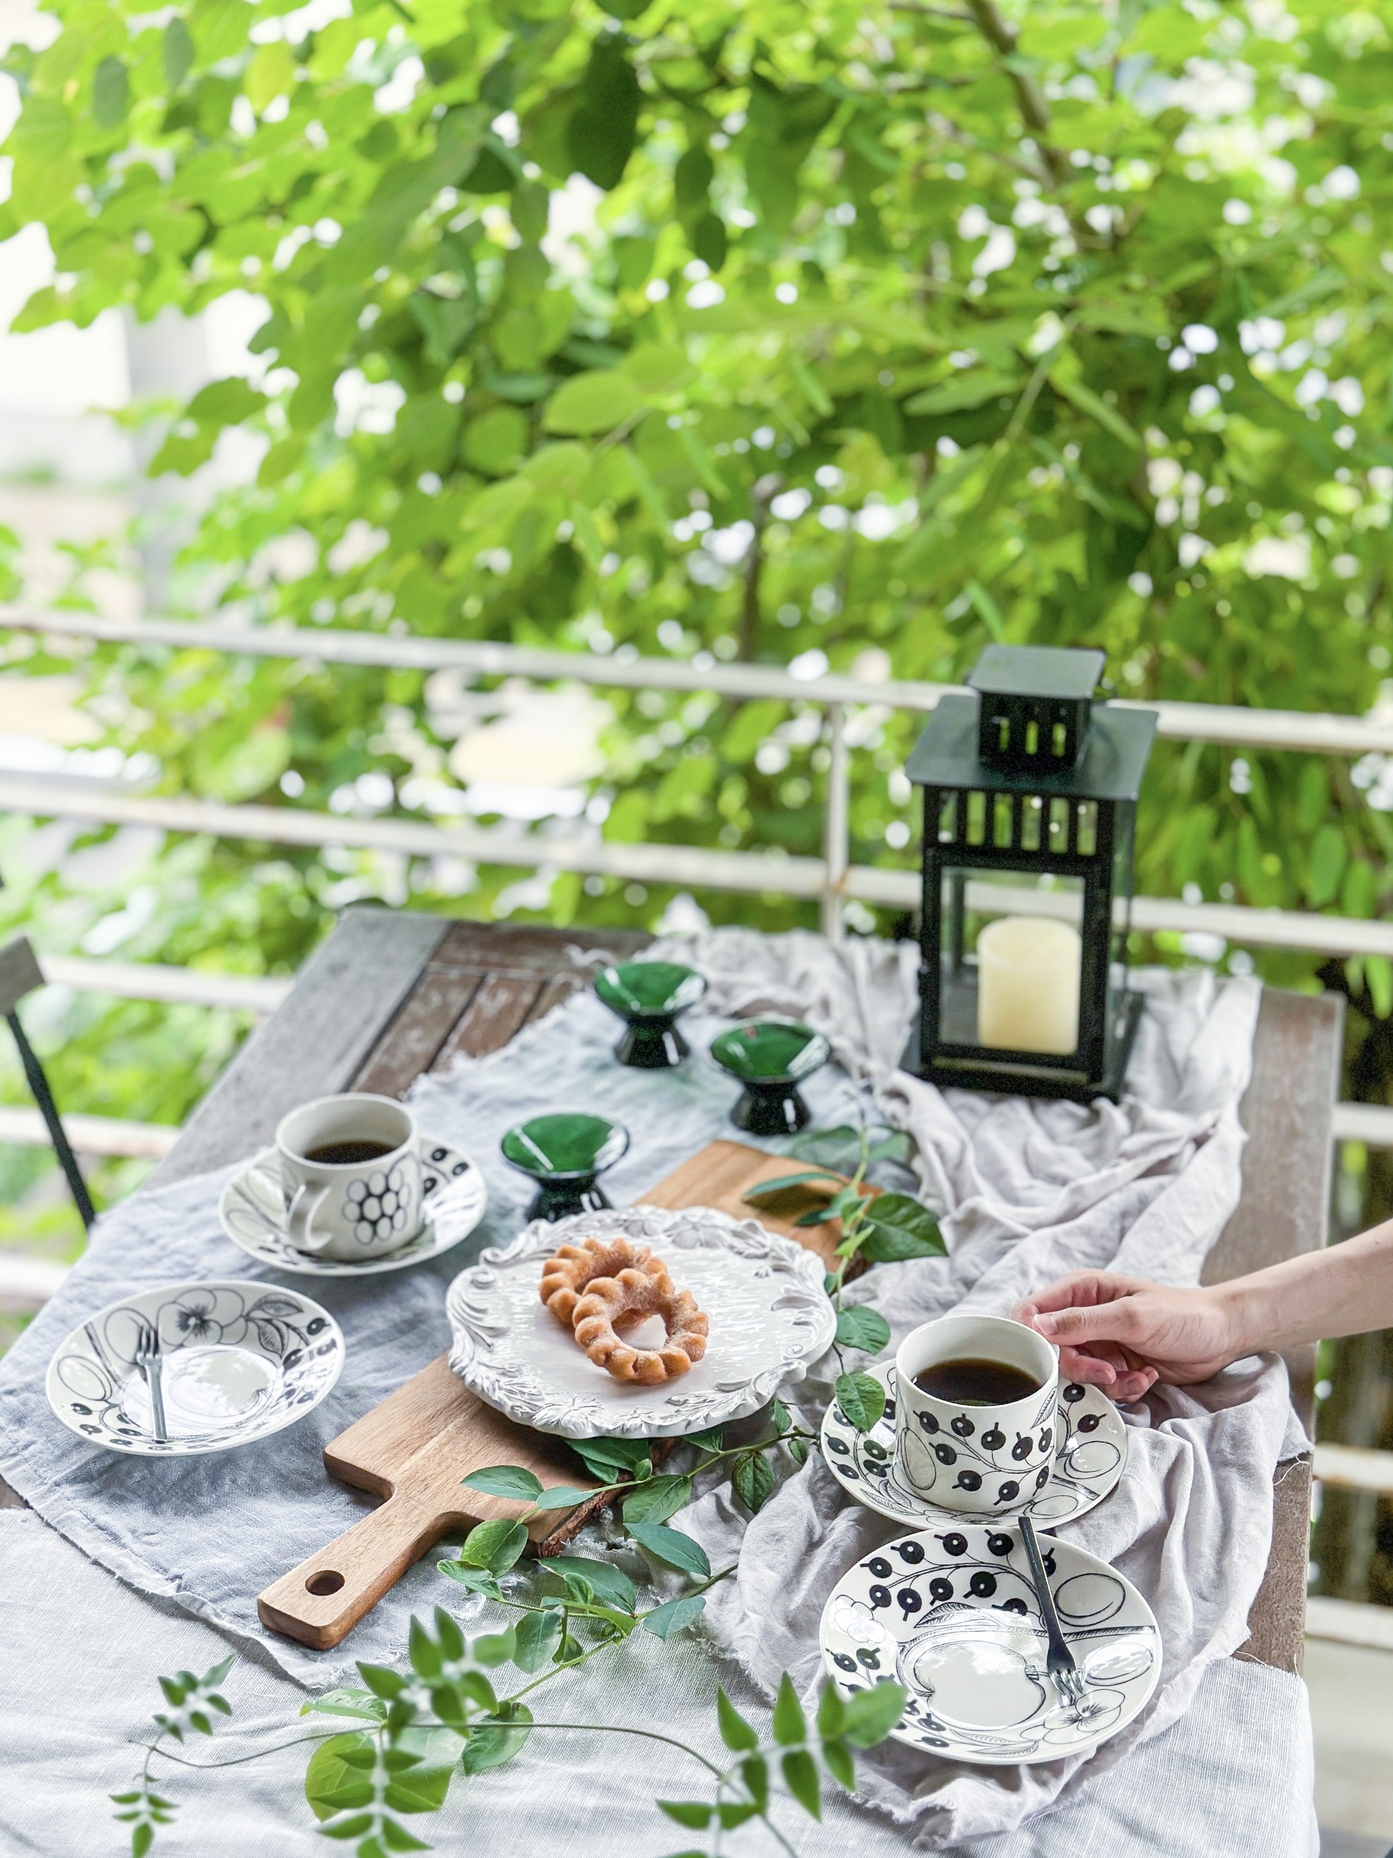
[0,604,1393,754]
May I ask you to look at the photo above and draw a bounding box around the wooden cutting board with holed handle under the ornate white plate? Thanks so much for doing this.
[256,1143,841,1652]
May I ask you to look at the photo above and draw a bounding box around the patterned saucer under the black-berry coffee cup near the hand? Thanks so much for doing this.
[823,1362,1127,1529]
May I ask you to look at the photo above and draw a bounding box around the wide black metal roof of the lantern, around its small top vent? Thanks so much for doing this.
[905,687,1157,801]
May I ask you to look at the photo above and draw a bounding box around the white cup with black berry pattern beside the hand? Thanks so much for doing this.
[895,1315,1059,1516]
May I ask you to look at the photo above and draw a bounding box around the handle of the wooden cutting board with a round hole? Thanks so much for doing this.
[256,1492,468,1652]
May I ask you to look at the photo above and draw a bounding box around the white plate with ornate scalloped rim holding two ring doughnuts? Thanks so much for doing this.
[446,1206,836,1438]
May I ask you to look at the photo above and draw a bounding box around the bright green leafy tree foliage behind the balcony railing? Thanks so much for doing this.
[0,0,1393,1218]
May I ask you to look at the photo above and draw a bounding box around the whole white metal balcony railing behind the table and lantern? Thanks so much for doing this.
[0,604,1393,1189]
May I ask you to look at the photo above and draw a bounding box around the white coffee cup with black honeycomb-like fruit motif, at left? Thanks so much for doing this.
[275,1093,422,1263]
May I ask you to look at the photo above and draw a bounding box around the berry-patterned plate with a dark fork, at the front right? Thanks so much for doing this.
[819,1524,1161,1763]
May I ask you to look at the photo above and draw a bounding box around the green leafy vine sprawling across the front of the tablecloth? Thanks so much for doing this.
[113,1520,906,1858]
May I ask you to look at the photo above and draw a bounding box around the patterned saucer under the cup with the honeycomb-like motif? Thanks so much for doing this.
[217,1139,488,1276]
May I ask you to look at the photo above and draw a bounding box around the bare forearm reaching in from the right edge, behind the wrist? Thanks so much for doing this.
[1215,1221,1393,1358]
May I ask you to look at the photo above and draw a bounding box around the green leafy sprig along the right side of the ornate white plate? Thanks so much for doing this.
[745,1124,945,1433]
